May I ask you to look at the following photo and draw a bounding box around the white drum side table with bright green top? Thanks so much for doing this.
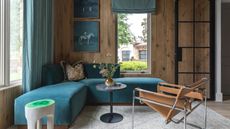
[25,99,55,129]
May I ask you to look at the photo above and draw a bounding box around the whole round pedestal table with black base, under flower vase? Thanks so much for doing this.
[96,83,127,123]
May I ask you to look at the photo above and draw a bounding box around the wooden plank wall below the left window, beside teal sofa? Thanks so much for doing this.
[0,86,22,129]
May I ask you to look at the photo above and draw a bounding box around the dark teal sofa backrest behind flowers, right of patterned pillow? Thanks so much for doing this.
[84,64,120,78]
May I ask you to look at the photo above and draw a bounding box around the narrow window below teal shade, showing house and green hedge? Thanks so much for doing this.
[117,13,151,73]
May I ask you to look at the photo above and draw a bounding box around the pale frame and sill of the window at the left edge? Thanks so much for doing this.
[0,0,21,87]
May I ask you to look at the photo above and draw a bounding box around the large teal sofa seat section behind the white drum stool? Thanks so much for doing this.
[15,82,87,125]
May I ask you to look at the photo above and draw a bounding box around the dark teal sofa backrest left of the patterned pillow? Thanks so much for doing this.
[42,64,64,86]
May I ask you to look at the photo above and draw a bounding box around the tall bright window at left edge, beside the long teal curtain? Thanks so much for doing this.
[0,0,23,86]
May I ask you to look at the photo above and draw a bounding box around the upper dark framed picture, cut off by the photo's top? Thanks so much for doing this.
[74,0,100,18]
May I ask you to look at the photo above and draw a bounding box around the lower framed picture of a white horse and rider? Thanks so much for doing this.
[74,21,100,52]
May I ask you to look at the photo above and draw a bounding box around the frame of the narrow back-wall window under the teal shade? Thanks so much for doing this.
[116,13,153,75]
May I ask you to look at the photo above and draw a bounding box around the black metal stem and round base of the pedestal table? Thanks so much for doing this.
[100,91,123,123]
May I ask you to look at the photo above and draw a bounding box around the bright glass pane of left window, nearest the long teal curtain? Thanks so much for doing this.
[10,0,23,81]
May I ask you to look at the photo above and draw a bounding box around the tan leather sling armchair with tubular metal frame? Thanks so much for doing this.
[132,78,208,129]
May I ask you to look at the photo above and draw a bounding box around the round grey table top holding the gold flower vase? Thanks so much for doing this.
[96,83,127,91]
